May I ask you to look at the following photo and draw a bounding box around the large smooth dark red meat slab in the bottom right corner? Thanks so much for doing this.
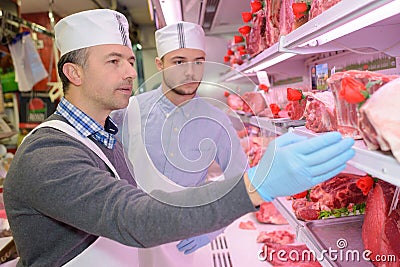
[362,180,400,267]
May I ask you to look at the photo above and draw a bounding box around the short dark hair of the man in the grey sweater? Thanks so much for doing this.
[57,48,89,94]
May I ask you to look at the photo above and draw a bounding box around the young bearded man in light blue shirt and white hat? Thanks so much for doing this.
[113,21,247,260]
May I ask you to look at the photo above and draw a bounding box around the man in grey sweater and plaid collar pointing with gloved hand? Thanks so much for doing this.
[4,9,354,266]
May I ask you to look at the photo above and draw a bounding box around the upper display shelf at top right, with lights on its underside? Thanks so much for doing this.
[221,0,400,80]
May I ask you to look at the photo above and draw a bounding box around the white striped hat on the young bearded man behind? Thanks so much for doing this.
[155,21,205,58]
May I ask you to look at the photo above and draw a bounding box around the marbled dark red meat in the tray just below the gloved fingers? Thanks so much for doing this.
[292,173,367,221]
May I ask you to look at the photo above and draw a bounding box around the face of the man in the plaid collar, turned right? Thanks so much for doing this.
[82,45,137,111]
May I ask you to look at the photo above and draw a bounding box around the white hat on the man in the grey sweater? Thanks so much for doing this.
[54,9,132,56]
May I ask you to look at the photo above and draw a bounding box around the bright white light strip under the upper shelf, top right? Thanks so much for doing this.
[299,1,400,47]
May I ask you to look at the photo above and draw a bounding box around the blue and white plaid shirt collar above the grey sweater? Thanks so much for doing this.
[55,97,118,149]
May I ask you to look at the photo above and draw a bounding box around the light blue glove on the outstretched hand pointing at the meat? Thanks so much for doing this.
[247,132,355,201]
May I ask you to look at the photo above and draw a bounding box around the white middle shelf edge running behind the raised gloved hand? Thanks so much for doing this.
[293,127,400,186]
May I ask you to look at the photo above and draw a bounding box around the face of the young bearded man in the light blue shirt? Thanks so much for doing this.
[159,48,205,95]
